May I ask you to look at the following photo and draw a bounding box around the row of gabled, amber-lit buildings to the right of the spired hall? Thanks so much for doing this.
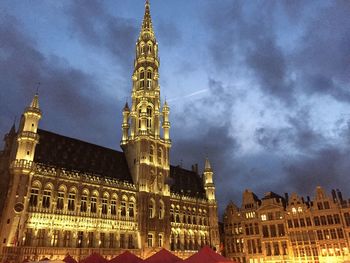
[224,187,350,263]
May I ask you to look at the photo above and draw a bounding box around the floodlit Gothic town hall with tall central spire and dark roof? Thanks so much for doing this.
[0,1,219,262]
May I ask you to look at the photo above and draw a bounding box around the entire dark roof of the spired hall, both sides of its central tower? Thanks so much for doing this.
[34,129,205,198]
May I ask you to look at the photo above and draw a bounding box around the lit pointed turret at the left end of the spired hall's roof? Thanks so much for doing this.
[16,94,41,161]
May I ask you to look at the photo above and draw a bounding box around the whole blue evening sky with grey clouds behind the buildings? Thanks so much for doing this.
[0,0,350,216]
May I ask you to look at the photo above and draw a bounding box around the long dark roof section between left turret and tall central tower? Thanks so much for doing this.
[34,129,132,183]
